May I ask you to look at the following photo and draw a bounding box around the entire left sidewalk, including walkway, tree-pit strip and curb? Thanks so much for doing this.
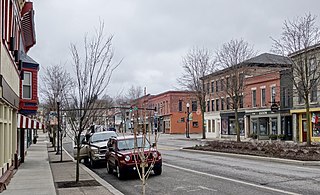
[2,132,122,195]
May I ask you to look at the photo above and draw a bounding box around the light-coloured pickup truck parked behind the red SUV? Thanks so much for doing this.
[74,131,118,167]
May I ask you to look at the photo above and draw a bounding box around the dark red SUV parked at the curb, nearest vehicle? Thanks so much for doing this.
[106,135,162,179]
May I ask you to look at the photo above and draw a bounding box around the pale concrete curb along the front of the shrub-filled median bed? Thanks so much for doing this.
[180,148,320,166]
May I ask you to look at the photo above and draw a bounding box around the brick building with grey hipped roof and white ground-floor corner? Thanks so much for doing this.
[201,53,290,138]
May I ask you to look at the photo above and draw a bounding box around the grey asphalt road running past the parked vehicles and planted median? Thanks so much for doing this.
[62,135,320,194]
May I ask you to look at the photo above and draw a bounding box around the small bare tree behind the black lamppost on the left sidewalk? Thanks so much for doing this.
[39,65,73,147]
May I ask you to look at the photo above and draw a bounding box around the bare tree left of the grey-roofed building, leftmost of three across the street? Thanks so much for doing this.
[178,47,214,139]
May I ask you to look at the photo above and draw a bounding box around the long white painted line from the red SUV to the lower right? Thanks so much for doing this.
[163,163,300,195]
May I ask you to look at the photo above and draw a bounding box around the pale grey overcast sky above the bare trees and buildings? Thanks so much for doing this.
[28,0,320,97]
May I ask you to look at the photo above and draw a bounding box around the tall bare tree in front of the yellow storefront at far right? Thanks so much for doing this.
[271,13,320,145]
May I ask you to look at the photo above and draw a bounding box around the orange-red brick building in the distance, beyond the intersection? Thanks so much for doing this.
[132,91,202,134]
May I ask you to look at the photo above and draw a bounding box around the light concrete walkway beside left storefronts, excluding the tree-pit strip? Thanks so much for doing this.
[2,132,56,195]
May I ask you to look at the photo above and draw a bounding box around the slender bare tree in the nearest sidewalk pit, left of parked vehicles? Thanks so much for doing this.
[65,22,121,182]
